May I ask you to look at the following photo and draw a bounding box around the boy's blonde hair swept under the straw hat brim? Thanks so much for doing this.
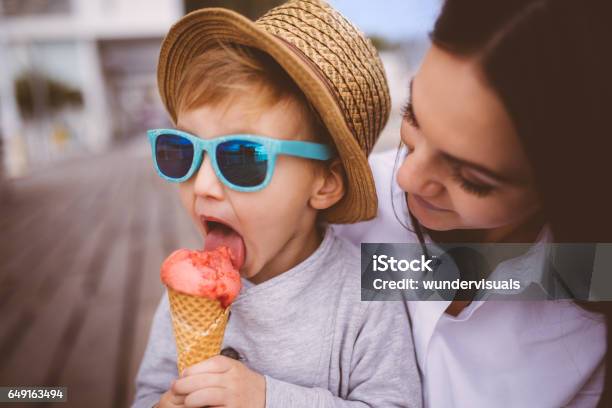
[177,43,333,147]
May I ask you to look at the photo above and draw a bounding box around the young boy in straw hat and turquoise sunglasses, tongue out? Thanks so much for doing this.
[134,0,421,408]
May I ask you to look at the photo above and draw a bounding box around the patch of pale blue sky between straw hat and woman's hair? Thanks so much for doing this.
[329,0,441,40]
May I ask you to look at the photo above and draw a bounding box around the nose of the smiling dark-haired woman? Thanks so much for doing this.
[397,147,444,197]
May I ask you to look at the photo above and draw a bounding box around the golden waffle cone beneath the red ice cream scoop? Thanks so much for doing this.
[168,288,229,373]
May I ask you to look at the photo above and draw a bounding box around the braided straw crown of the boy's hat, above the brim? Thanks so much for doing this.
[255,1,391,155]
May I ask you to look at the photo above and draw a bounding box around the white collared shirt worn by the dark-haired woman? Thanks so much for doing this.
[334,150,606,408]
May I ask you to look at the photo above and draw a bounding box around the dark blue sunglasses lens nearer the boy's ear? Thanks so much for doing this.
[216,140,268,187]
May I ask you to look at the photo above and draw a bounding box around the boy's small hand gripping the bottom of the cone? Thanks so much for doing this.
[172,356,266,408]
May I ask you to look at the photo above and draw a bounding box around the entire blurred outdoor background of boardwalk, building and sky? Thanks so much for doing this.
[0,0,441,407]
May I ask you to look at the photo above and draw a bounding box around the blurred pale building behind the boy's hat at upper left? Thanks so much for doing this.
[0,0,184,176]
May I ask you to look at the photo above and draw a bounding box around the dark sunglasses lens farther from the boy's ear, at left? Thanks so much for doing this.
[155,134,193,179]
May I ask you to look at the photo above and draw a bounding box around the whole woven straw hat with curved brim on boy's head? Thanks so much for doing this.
[157,0,391,223]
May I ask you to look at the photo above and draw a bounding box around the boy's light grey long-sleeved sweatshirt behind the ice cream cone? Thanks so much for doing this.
[133,228,421,408]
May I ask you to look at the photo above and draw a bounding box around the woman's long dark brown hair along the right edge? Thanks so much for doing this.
[420,0,612,407]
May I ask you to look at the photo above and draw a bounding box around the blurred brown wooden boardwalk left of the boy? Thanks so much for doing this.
[0,137,201,408]
